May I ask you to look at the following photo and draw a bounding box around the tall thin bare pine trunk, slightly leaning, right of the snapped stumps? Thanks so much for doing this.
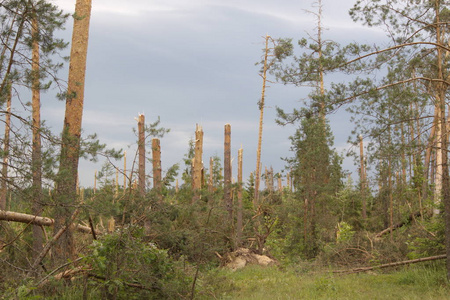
[253,35,270,209]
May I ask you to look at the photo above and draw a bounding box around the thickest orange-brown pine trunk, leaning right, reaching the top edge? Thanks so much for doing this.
[54,0,91,260]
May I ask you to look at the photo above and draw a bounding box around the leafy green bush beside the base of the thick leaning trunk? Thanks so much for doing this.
[82,226,192,299]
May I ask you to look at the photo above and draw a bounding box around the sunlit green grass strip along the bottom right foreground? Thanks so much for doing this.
[197,262,450,300]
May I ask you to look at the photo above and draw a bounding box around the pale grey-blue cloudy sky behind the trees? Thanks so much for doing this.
[42,0,382,187]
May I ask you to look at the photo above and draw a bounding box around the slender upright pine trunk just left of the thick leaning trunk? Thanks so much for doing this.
[31,11,44,259]
